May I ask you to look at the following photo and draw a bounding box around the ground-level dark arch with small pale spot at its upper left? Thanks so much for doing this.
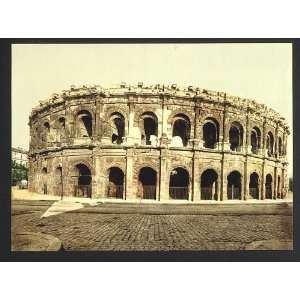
[169,168,189,200]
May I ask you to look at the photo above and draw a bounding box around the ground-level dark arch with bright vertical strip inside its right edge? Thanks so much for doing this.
[201,169,218,200]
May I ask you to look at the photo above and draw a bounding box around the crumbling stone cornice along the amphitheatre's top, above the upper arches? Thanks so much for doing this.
[30,83,290,133]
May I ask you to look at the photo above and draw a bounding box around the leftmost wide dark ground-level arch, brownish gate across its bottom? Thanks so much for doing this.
[75,164,92,198]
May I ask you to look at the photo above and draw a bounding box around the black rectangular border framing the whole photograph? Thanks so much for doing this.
[0,38,300,261]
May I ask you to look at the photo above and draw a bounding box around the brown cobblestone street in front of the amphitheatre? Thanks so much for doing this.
[12,201,292,251]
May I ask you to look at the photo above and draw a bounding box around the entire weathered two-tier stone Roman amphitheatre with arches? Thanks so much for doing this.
[29,83,290,202]
